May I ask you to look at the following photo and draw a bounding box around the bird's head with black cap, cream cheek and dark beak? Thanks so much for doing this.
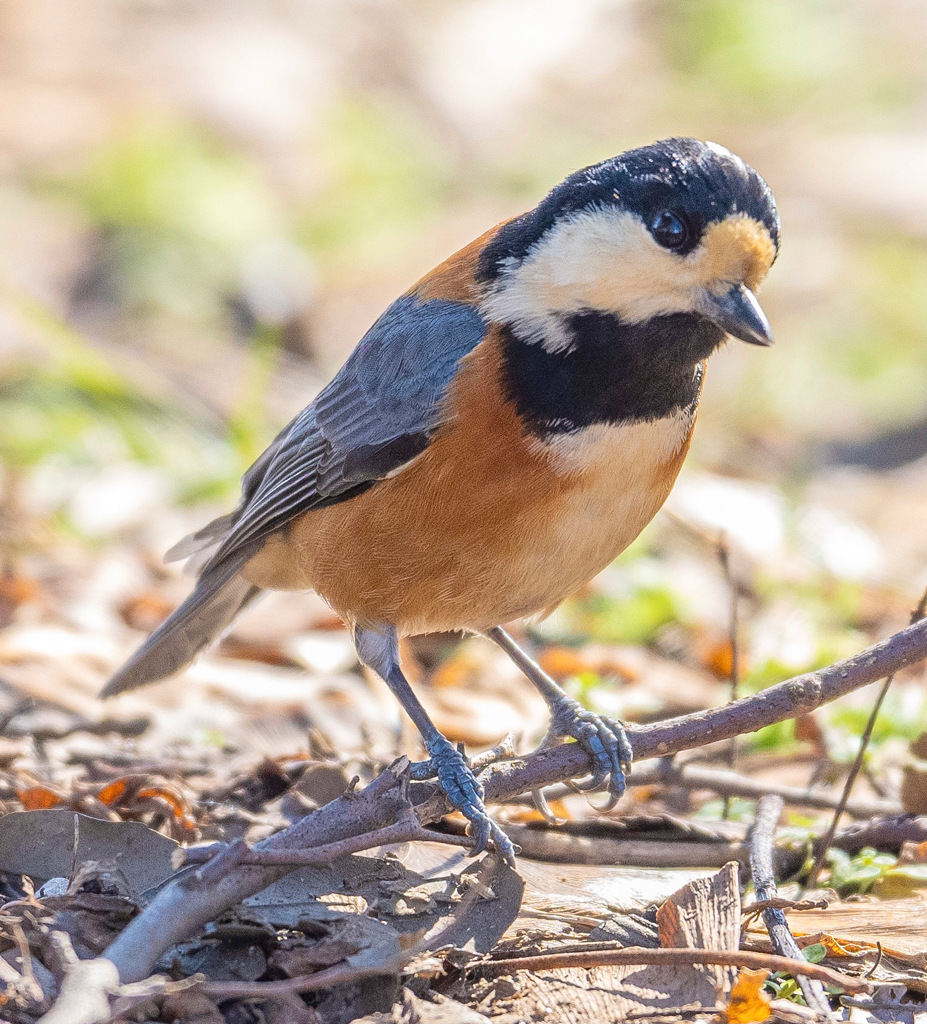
[480,138,779,350]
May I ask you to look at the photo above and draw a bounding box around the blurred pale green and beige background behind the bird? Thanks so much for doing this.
[0,0,927,794]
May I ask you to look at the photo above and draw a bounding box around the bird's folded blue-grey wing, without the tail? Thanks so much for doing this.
[201,296,487,568]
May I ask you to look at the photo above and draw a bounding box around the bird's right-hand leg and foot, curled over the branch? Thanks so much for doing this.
[484,626,633,809]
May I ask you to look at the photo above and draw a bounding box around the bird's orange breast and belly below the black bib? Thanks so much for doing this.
[245,332,692,634]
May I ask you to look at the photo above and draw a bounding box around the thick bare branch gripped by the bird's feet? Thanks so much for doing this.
[36,620,927,1024]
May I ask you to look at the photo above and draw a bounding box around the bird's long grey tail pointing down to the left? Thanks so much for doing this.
[100,551,261,697]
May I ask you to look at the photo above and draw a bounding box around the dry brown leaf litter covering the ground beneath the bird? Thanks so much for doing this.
[0,512,927,1024]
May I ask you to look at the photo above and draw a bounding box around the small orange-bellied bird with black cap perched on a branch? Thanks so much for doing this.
[101,138,779,862]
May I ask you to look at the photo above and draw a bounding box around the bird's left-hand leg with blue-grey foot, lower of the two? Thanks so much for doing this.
[354,626,515,864]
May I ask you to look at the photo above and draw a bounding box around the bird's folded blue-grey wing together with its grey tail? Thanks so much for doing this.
[103,295,486,695]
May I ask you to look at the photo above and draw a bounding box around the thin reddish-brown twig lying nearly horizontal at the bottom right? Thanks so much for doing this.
[464,946,872,992]
